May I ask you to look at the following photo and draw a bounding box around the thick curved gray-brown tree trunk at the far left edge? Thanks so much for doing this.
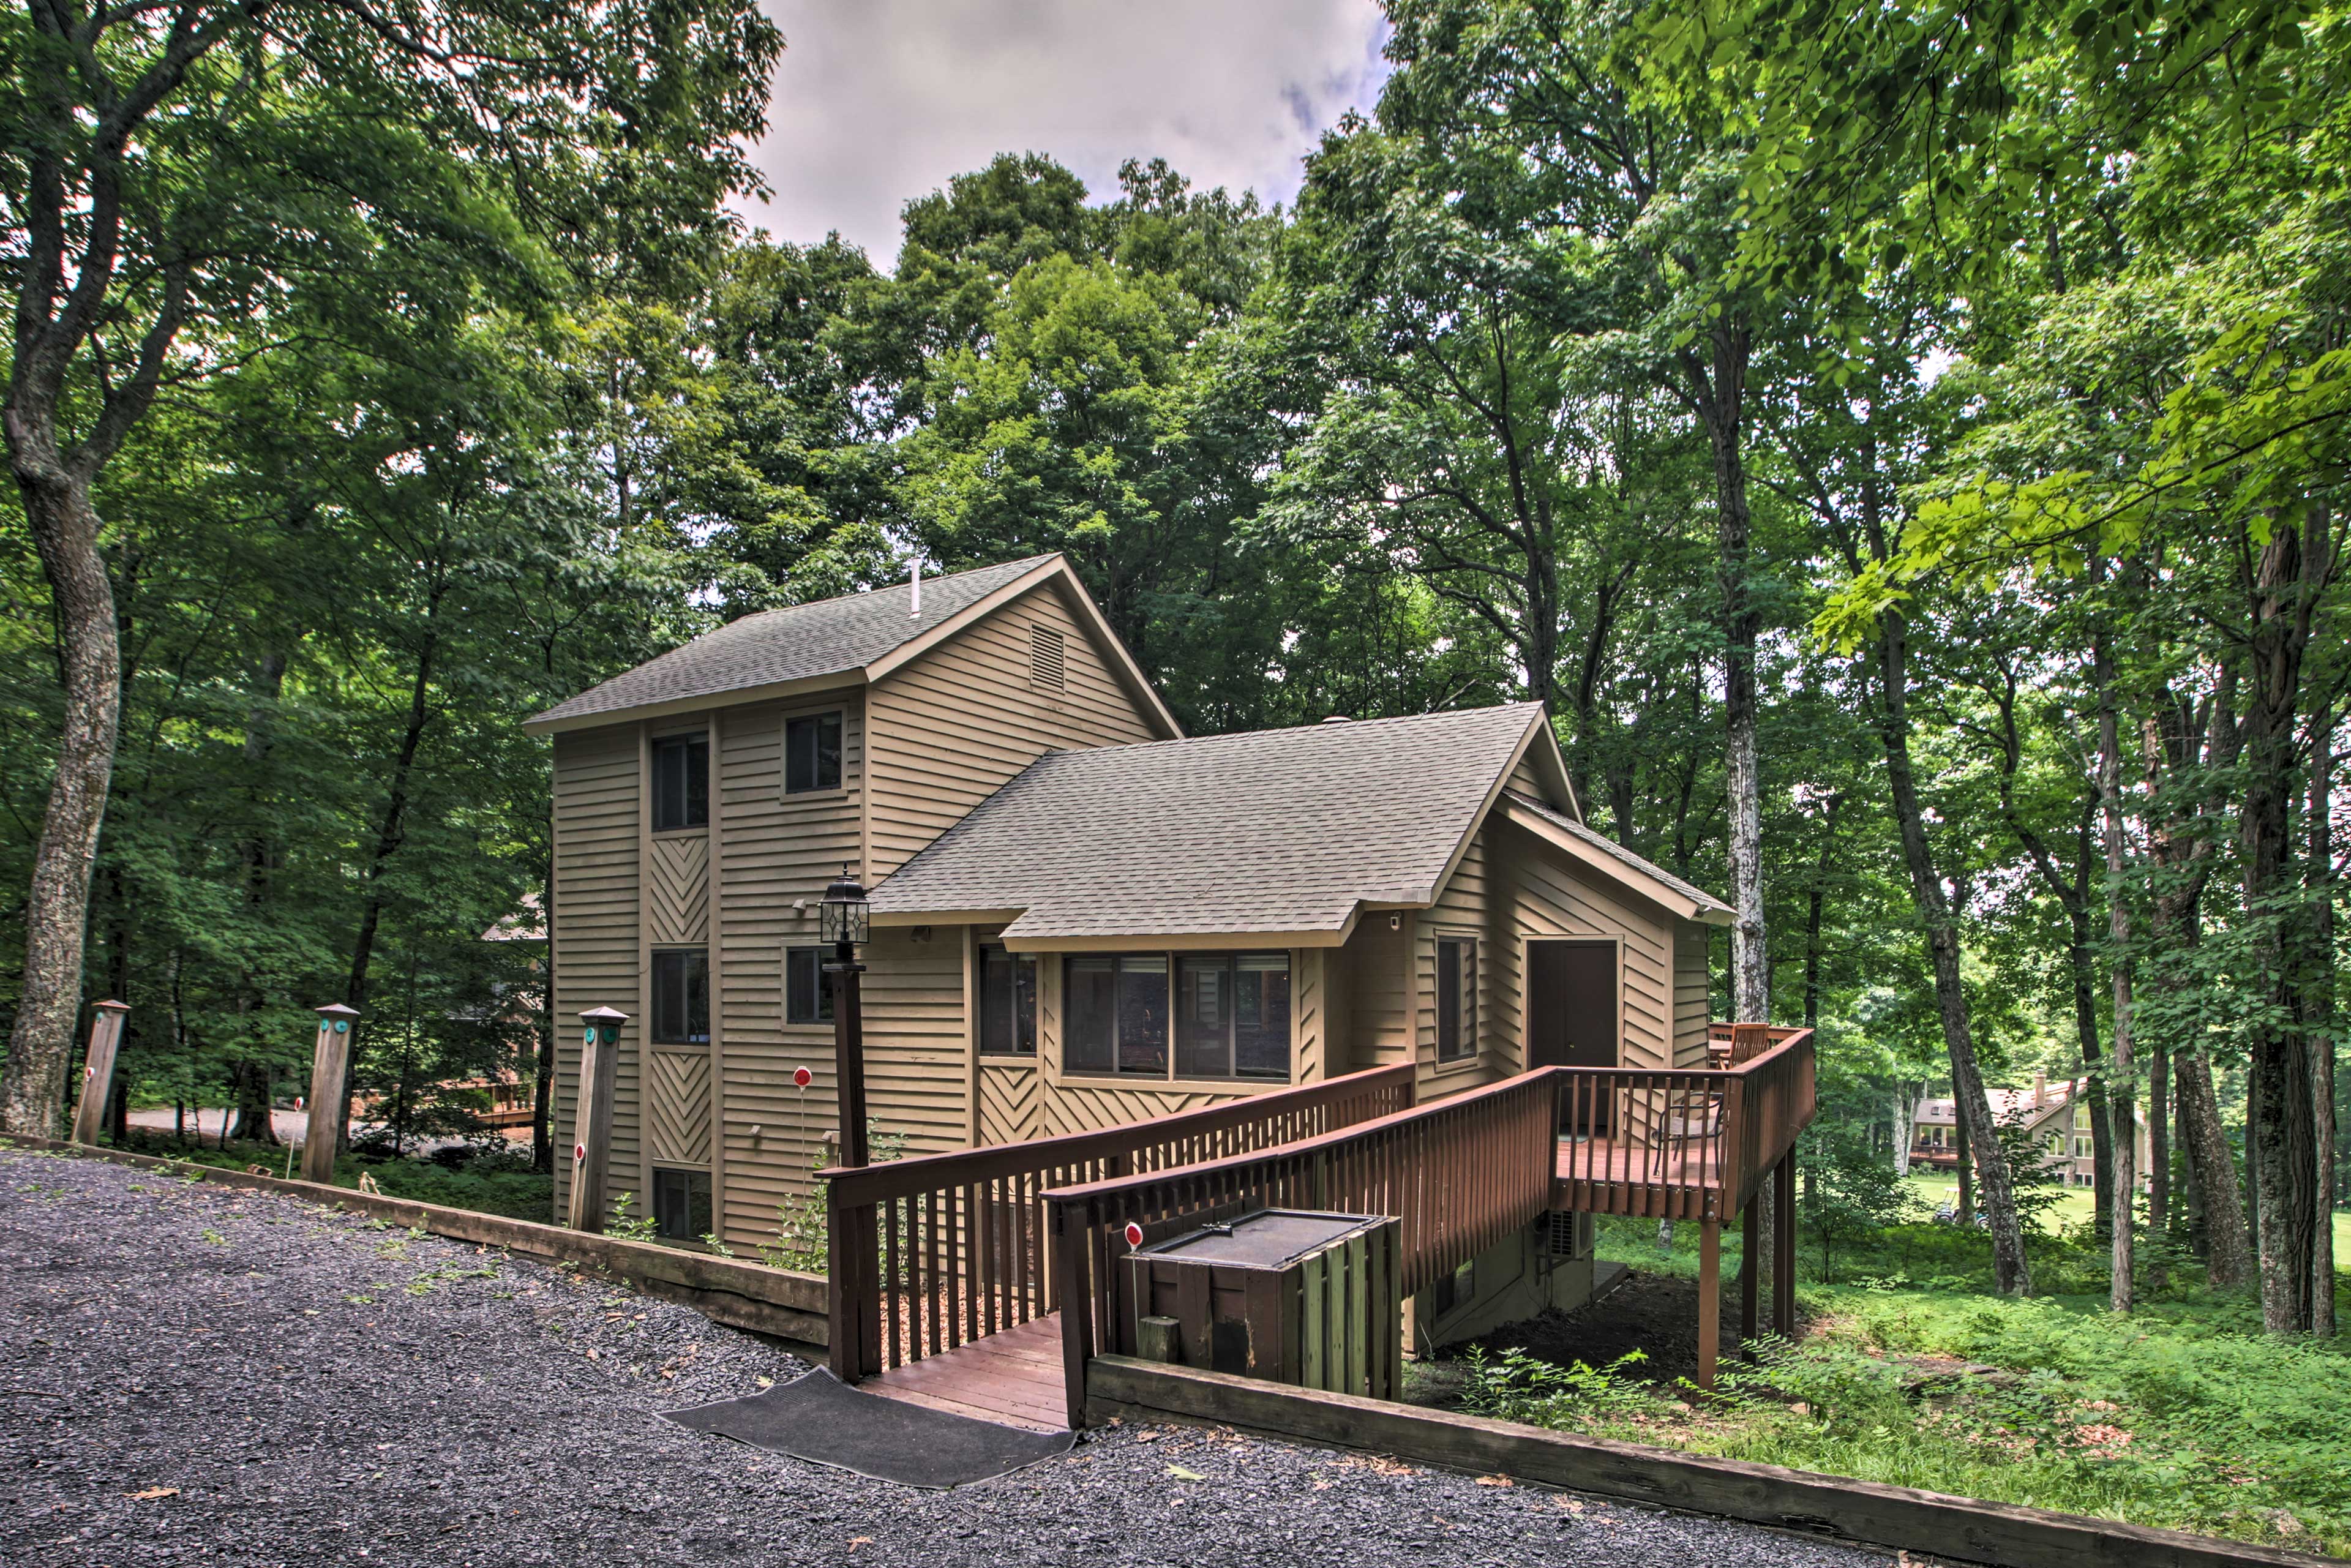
[0,472,122,1138]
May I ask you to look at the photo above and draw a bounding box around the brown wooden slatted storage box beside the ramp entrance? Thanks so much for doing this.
[1126,1209,1403,1399]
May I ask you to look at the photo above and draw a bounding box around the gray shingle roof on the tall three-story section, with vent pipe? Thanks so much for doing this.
[531,555,1053,724]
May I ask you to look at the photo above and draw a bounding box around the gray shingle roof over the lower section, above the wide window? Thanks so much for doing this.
[872,703,1542,938]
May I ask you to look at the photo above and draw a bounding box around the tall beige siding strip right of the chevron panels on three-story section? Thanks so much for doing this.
[714,689,865,1248]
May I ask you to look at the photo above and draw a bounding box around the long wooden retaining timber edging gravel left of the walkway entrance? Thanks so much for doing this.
[0,1133,825,1345]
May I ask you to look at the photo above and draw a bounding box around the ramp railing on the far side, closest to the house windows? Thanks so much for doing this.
[825,1065,1413,1382]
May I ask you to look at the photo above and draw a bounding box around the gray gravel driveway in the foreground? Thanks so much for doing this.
[0,1154,1886,1568]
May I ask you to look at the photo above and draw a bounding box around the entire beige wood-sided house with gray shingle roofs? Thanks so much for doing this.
[529,555,1728,1248]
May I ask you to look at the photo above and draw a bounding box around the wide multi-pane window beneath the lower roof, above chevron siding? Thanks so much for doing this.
[1060,952,1291,1081]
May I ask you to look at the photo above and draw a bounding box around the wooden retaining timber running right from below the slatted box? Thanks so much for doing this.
[1084,1356,2342,1568]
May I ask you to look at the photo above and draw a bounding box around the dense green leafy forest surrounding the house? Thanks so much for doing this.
[0,0,2351,1333]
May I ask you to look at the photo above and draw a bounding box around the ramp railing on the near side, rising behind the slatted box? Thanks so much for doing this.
[1044,1070,1559,1427]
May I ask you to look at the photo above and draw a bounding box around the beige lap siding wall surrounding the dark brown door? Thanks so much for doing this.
[1488,828,1676,1067]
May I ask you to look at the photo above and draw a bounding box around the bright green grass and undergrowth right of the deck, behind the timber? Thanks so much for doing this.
[1561,1213,2351,1554]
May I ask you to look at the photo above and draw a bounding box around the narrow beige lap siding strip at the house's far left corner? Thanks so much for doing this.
[552,724,644,1213]
